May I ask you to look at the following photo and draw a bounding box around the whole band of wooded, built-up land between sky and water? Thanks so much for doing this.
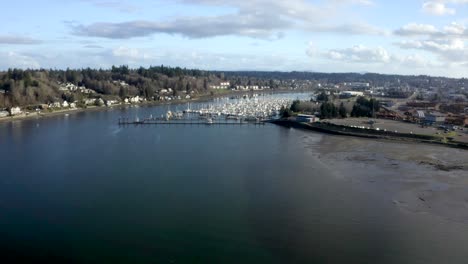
[0,66,468,140]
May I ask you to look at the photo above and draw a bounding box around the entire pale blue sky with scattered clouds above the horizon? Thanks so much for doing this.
[0,0,468,77]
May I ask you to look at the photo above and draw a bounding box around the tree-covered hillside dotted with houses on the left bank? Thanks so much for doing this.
[0,66,276,108]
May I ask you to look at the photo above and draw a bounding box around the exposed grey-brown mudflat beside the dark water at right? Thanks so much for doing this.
[315,135,468,223]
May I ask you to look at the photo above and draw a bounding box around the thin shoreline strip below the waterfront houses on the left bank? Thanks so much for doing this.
[0,89,307,124]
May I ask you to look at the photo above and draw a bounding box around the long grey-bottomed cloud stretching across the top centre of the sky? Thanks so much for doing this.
[70,0,384,39]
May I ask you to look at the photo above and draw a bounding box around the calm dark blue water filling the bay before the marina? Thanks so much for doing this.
[0,94,468,263]
